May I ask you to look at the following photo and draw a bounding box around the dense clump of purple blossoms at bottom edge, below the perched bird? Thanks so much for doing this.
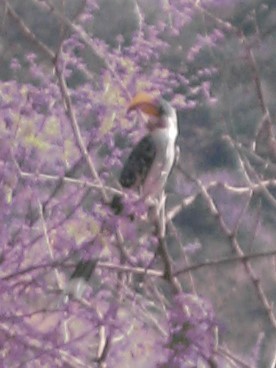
[160,293,217,368]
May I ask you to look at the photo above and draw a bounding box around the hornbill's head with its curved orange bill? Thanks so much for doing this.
[127,92,177,131]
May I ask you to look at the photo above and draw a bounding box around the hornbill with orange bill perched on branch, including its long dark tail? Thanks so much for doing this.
[63,92,178,297]
